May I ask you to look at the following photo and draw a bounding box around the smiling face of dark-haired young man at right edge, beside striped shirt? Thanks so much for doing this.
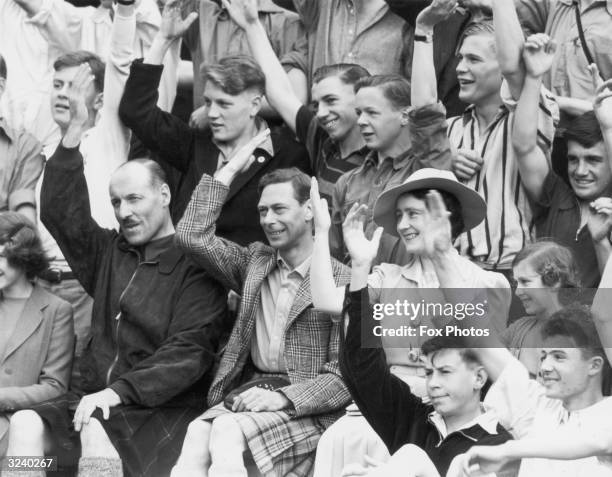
[567,141,612,201]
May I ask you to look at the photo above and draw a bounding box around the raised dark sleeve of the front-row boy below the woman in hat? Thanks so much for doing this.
[340,288,427,453]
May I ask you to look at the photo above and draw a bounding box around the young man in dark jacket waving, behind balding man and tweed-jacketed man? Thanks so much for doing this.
[119,0,310,245]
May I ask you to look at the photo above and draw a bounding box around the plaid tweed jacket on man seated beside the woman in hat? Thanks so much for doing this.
[176,174,351,427]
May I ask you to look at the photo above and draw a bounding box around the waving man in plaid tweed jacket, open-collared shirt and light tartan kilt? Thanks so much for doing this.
[173,131,350,477]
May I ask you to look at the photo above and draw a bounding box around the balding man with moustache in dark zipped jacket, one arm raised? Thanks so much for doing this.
[7,61,226,475]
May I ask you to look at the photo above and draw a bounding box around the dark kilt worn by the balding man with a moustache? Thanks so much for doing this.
[32,393,202,477]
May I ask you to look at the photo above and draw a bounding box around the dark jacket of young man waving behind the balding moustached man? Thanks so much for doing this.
[119,60,311,245]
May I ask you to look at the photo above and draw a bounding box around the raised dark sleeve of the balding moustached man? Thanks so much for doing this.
[40,143,117,296]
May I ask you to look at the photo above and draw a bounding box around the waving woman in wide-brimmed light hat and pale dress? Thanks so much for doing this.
[311,168,511,477]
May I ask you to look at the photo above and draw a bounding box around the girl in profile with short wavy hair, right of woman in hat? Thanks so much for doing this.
[500,241,580,377]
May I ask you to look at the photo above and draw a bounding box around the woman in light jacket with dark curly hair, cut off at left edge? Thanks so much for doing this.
[0,212,74,457]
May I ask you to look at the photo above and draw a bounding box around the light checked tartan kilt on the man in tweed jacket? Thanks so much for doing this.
[198,403,325,477]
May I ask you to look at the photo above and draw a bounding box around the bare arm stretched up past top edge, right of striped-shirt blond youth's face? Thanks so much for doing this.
[490,0,525,99]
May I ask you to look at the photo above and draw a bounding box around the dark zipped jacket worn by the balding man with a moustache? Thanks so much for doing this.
[41,145,227,407]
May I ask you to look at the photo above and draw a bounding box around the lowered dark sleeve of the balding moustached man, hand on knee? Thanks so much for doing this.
[109,266,227,407]
